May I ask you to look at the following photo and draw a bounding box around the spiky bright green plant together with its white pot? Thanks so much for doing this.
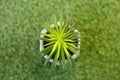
[40,22,80,68]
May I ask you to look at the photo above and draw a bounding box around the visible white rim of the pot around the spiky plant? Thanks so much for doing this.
[40,24,80,65]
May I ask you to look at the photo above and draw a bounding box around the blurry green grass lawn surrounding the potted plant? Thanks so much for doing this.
[0,0,120,80]
